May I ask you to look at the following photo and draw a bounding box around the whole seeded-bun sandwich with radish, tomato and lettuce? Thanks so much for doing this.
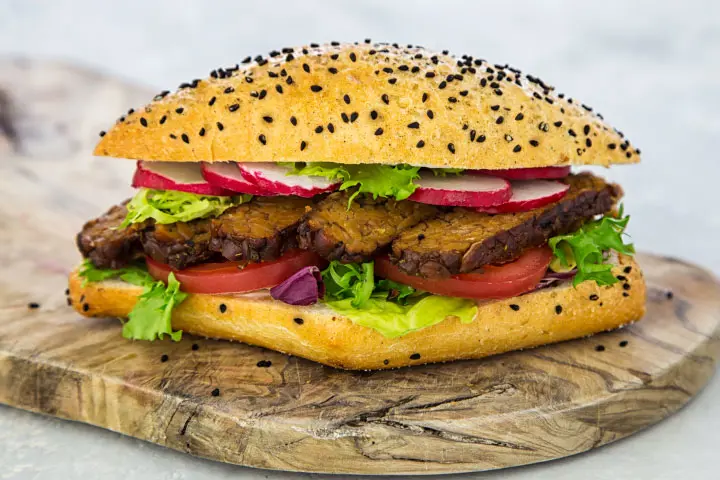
[69,40,645,370]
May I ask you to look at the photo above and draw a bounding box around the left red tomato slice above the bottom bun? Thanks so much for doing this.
[145,249,326,293]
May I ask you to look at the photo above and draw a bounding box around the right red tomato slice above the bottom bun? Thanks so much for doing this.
[375,246,552,299]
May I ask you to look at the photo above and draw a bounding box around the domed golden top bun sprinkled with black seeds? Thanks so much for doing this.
[95,41,640,169]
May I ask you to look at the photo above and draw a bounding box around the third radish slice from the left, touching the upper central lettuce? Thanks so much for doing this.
[238,162,340,198]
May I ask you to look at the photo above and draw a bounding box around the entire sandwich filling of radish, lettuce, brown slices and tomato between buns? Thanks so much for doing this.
[77,162,634,340]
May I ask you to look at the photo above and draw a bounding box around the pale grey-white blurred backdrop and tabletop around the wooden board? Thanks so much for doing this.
[0,0,720,479]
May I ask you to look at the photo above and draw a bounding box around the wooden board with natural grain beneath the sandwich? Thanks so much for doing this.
[0,59,720,474]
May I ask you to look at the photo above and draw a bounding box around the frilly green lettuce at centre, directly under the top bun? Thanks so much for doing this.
[283,162,462,206]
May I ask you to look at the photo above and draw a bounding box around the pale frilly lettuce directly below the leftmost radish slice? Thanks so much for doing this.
[120,188,252,228]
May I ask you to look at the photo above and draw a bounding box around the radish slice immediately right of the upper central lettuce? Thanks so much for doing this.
[408,172,510,207]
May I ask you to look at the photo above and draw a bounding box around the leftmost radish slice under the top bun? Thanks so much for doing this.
[132,161,232,196]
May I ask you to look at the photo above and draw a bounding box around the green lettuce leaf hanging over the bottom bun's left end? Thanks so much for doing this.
[79,260,187,342]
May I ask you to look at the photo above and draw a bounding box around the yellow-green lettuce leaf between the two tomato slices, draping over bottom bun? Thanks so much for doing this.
[322,261,477,338]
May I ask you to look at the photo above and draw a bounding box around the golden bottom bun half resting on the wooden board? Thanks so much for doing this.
[70,256,645,370]
